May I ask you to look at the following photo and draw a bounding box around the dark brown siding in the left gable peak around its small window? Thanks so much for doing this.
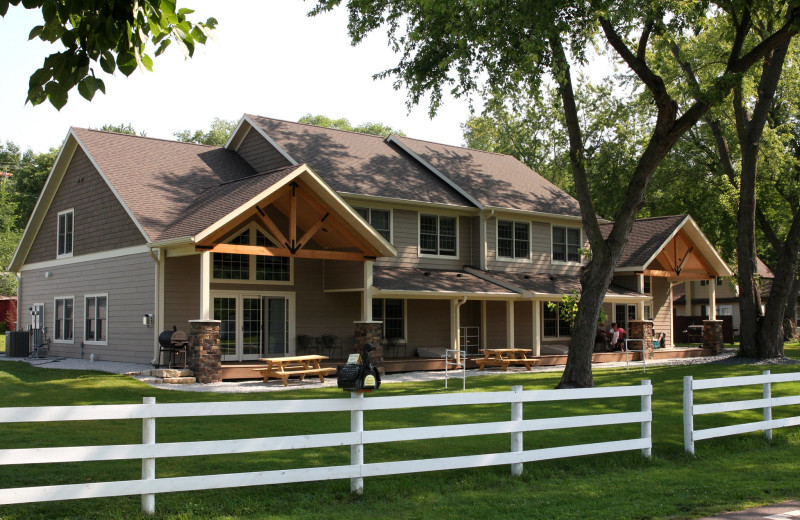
[25,147,146,263]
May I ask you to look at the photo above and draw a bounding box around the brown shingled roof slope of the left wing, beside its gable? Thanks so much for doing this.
[72,128,256,241]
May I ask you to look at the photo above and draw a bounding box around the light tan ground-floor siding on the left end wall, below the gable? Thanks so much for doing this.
[19,253,156,363]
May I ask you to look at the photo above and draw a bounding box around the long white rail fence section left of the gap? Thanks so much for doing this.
[0,381,652,513]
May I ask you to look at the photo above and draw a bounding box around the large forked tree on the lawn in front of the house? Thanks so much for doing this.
[312,0,800,388]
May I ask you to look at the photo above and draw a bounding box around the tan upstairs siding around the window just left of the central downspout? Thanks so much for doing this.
[376,209,478,270]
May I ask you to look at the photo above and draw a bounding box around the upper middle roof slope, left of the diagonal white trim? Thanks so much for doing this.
[245,115,472,207]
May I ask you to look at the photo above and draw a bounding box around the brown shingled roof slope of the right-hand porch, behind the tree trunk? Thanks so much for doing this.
[600,215,687,268]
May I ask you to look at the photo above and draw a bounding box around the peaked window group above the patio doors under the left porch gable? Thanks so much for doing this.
[211,225,291,282]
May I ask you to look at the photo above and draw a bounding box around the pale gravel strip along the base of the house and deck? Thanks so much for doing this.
[6,349,800,393]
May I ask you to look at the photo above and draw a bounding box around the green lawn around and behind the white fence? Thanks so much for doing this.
[0,344,800,520]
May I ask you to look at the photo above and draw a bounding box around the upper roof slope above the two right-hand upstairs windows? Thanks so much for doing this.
[394,136,580,217]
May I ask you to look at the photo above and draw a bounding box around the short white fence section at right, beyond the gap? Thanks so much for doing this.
[683,370,800,454]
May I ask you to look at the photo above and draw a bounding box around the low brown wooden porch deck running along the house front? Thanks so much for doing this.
[216,347,711,381]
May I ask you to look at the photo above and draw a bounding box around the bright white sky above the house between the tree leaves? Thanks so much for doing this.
[0,0,480,152]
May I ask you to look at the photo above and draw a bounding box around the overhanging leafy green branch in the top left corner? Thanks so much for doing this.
[0,0,217,110]
